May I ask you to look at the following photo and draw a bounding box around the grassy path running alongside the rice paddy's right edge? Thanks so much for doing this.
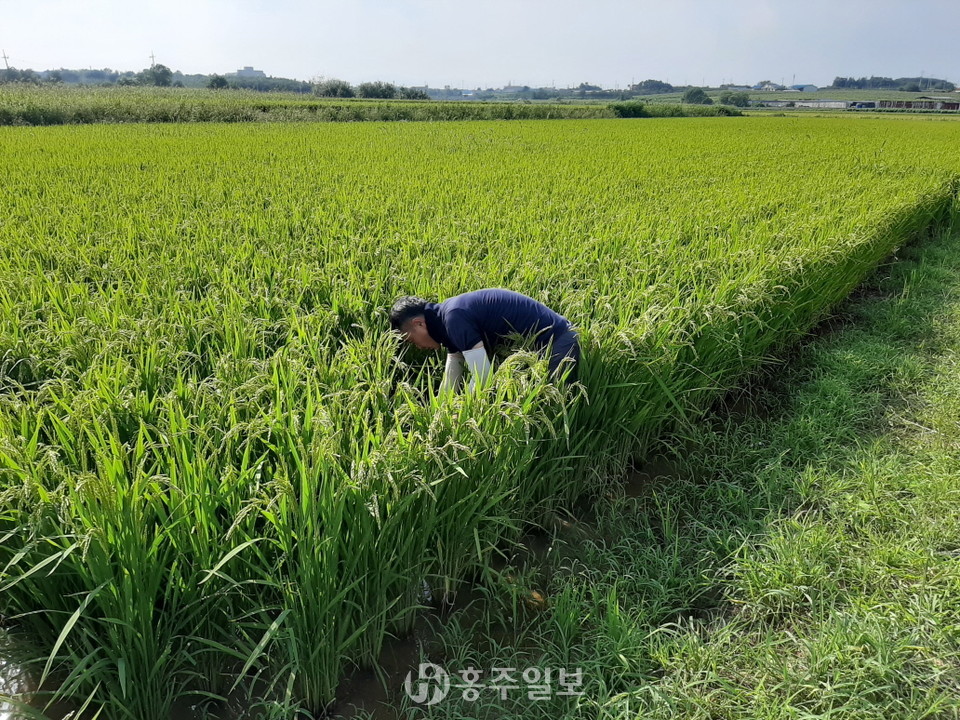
[366,221,960,720]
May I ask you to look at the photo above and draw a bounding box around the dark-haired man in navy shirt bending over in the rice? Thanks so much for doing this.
[390,288,580,392]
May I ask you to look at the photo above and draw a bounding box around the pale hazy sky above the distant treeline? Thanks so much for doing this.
[0,0,960,87]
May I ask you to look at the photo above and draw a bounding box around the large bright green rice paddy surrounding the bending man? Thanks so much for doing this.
[0,118,960,720]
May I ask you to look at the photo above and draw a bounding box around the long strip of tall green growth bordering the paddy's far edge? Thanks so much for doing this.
[0,85,731,125]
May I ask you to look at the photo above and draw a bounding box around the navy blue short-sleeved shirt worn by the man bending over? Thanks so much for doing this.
[423,288,571,353]
